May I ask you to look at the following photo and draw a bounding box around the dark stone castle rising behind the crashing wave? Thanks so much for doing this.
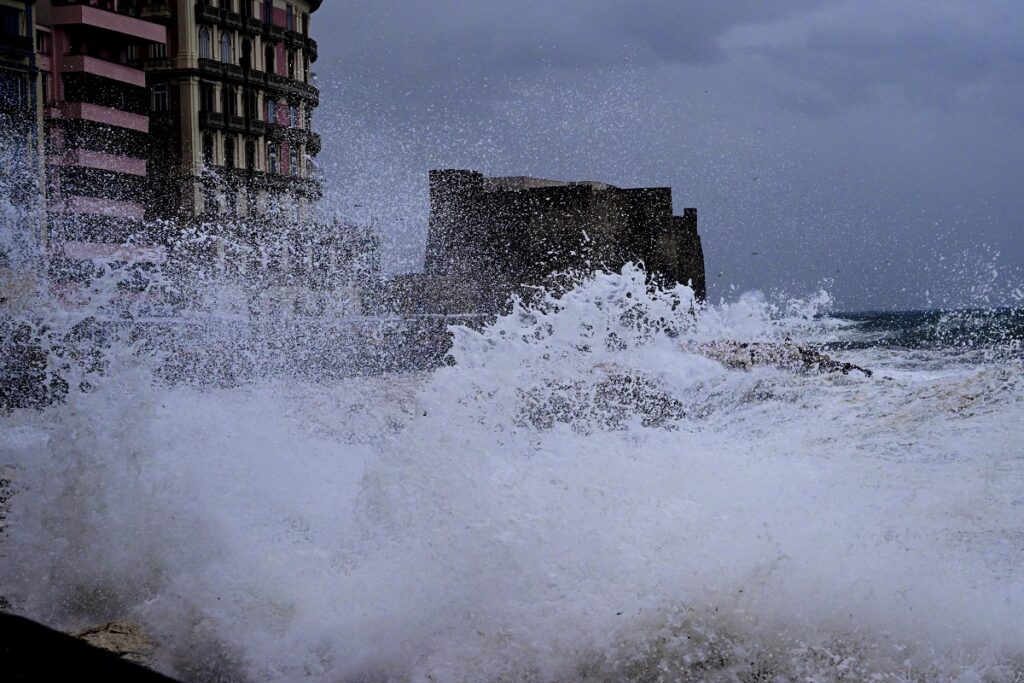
[395,170,707,313]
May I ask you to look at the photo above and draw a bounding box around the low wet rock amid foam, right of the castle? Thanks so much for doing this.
[695,341,873,377]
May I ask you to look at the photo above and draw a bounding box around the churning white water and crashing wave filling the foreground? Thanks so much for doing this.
[0,268,1024,683]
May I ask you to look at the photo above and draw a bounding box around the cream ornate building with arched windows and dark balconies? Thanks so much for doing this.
[139,0,321,227]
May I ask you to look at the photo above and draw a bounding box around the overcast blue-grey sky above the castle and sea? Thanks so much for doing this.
[312,0,1024,309]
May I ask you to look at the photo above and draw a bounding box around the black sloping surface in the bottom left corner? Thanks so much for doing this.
[0,613,173,682]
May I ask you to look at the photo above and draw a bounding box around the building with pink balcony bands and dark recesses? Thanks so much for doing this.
[36,0,167,270]
